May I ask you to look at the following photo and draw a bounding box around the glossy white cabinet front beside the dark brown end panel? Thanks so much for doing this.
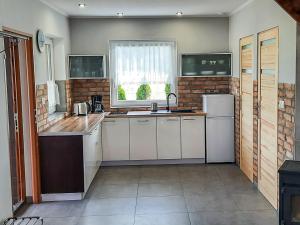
[83,125,102,192]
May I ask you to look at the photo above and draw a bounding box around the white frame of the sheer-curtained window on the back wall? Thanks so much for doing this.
[109,40,179,108]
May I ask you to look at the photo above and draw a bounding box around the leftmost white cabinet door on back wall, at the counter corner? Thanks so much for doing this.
[102,118,129,161]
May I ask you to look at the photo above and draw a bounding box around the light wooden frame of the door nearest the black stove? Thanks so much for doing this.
[257,26,280,207]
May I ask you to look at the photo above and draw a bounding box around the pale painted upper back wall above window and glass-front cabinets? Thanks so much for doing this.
[70,18,229,55]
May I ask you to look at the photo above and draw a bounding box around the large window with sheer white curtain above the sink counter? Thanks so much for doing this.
[110,41,177,107]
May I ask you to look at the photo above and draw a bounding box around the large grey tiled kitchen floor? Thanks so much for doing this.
[17,165,278,225]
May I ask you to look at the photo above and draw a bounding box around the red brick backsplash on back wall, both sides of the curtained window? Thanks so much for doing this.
[72,77,230,111]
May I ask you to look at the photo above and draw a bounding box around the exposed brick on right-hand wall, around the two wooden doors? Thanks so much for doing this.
[230,78,295,183]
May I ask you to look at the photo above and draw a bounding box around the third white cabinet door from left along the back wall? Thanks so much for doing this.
[157,117,181,159]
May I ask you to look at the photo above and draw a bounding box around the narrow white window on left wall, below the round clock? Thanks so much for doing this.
[45,38,60,115]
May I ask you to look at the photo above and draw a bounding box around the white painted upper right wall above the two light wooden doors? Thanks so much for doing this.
[229,0,297,83]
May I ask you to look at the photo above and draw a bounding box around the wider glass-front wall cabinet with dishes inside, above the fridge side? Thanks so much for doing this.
[181,53,232,76]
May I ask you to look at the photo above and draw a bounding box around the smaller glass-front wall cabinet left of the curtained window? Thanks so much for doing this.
[69,55,106,79]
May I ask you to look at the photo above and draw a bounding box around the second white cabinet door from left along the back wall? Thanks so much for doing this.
[130,117,157,160]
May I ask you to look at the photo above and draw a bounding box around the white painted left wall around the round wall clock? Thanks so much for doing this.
[0,0,70,84]
